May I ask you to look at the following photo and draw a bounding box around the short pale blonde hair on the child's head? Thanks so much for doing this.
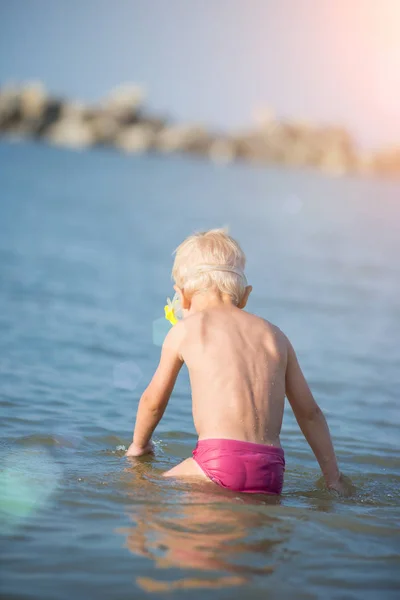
[172,229,247,305]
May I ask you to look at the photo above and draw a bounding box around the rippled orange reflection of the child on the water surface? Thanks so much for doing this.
[119,465,291,591]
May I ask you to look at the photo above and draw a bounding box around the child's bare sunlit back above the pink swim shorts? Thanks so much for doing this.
[174,305,287,446]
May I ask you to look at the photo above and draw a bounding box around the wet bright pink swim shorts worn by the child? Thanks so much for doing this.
[193,439,285,494]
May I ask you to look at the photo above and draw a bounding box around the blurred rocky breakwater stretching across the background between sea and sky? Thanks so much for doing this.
[0,83,400,176]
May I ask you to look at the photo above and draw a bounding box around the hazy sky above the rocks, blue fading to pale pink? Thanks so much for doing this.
[0,0,400,148]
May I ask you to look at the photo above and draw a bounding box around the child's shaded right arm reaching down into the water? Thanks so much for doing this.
[286,341,343,493]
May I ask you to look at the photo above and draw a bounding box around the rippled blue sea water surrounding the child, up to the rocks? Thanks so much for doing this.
[0,143,400,600]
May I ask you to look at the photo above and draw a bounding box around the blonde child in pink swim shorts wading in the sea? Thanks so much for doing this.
[126,229,344,494]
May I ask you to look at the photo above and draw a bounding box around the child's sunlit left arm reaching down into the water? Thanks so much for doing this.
[126,324,183,456]
